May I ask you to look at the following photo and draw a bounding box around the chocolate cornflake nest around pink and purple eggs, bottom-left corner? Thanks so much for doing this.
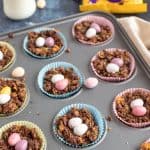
[0,125,42,150]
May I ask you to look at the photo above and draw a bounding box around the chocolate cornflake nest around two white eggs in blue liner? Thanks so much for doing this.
[56,107,100,146]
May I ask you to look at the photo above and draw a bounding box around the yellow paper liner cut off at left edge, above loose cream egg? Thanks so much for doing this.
[0,41,16,72]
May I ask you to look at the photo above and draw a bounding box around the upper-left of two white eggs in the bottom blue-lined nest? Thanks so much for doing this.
[68,117,82,128]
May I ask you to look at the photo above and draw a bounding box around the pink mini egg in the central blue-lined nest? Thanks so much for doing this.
[55,79,69,91]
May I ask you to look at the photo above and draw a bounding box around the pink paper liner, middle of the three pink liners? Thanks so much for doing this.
[90,48,136,82]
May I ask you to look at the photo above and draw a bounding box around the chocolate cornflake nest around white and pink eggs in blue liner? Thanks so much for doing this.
[43,67,80,95]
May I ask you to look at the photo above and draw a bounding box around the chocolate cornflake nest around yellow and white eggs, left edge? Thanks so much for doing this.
[0,78,27,116]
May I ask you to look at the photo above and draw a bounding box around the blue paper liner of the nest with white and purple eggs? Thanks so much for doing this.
[23,28,67,60]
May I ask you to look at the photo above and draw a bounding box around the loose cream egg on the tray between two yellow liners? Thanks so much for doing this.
[12,67,25,78]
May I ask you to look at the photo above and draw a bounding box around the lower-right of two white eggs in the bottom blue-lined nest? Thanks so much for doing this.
[73,124,88,136]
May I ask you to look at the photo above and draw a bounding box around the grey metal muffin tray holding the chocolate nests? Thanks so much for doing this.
[0,11,150,150]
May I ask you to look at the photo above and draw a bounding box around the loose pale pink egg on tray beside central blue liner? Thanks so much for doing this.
[84,77,98,89]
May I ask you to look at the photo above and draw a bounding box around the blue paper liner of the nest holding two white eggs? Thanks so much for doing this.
[53,103,107,148]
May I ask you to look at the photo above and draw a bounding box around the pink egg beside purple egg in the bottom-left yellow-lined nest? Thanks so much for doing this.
[8,133,21,146]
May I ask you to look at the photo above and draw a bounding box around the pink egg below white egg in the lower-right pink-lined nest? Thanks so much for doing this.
[132,106,147,117]
